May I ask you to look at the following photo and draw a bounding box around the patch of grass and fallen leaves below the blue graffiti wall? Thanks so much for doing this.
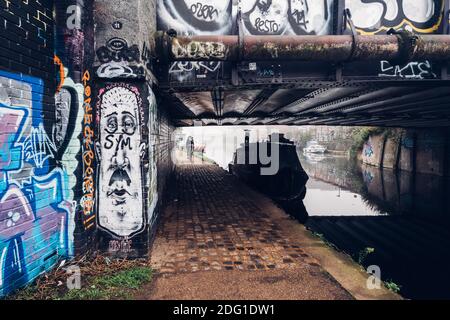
[7,256,153,300]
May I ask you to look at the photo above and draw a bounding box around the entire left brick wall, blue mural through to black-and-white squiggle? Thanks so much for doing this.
[0,0,95,296]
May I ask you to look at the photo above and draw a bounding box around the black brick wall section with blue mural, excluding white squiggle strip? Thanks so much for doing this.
[0,0,76,296]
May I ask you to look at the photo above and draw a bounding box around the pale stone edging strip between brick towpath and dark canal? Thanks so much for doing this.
[246,174,404,300]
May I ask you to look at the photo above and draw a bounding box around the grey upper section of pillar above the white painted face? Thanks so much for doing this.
[94,0,156,81]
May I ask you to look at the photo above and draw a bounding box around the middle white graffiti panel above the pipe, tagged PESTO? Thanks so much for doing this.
[242,0,334,35]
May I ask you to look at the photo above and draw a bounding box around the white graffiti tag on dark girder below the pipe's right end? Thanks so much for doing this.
[378,61,437,80]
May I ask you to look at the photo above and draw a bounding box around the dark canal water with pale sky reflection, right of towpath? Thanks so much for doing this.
[301,155,450,299]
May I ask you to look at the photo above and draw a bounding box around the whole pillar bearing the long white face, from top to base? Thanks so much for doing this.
[93,0,161,258]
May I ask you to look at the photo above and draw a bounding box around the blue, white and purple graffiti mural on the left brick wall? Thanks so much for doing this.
[0,71,75,295]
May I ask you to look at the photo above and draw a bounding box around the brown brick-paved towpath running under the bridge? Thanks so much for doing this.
[138,164,352,299]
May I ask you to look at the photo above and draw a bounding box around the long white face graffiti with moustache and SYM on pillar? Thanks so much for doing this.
[97,86,145,237]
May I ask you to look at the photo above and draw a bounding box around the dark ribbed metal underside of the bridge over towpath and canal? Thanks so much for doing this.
[162,81,450,127]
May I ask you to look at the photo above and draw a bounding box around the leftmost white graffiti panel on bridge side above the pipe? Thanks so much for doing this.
[157,0,233,35]
